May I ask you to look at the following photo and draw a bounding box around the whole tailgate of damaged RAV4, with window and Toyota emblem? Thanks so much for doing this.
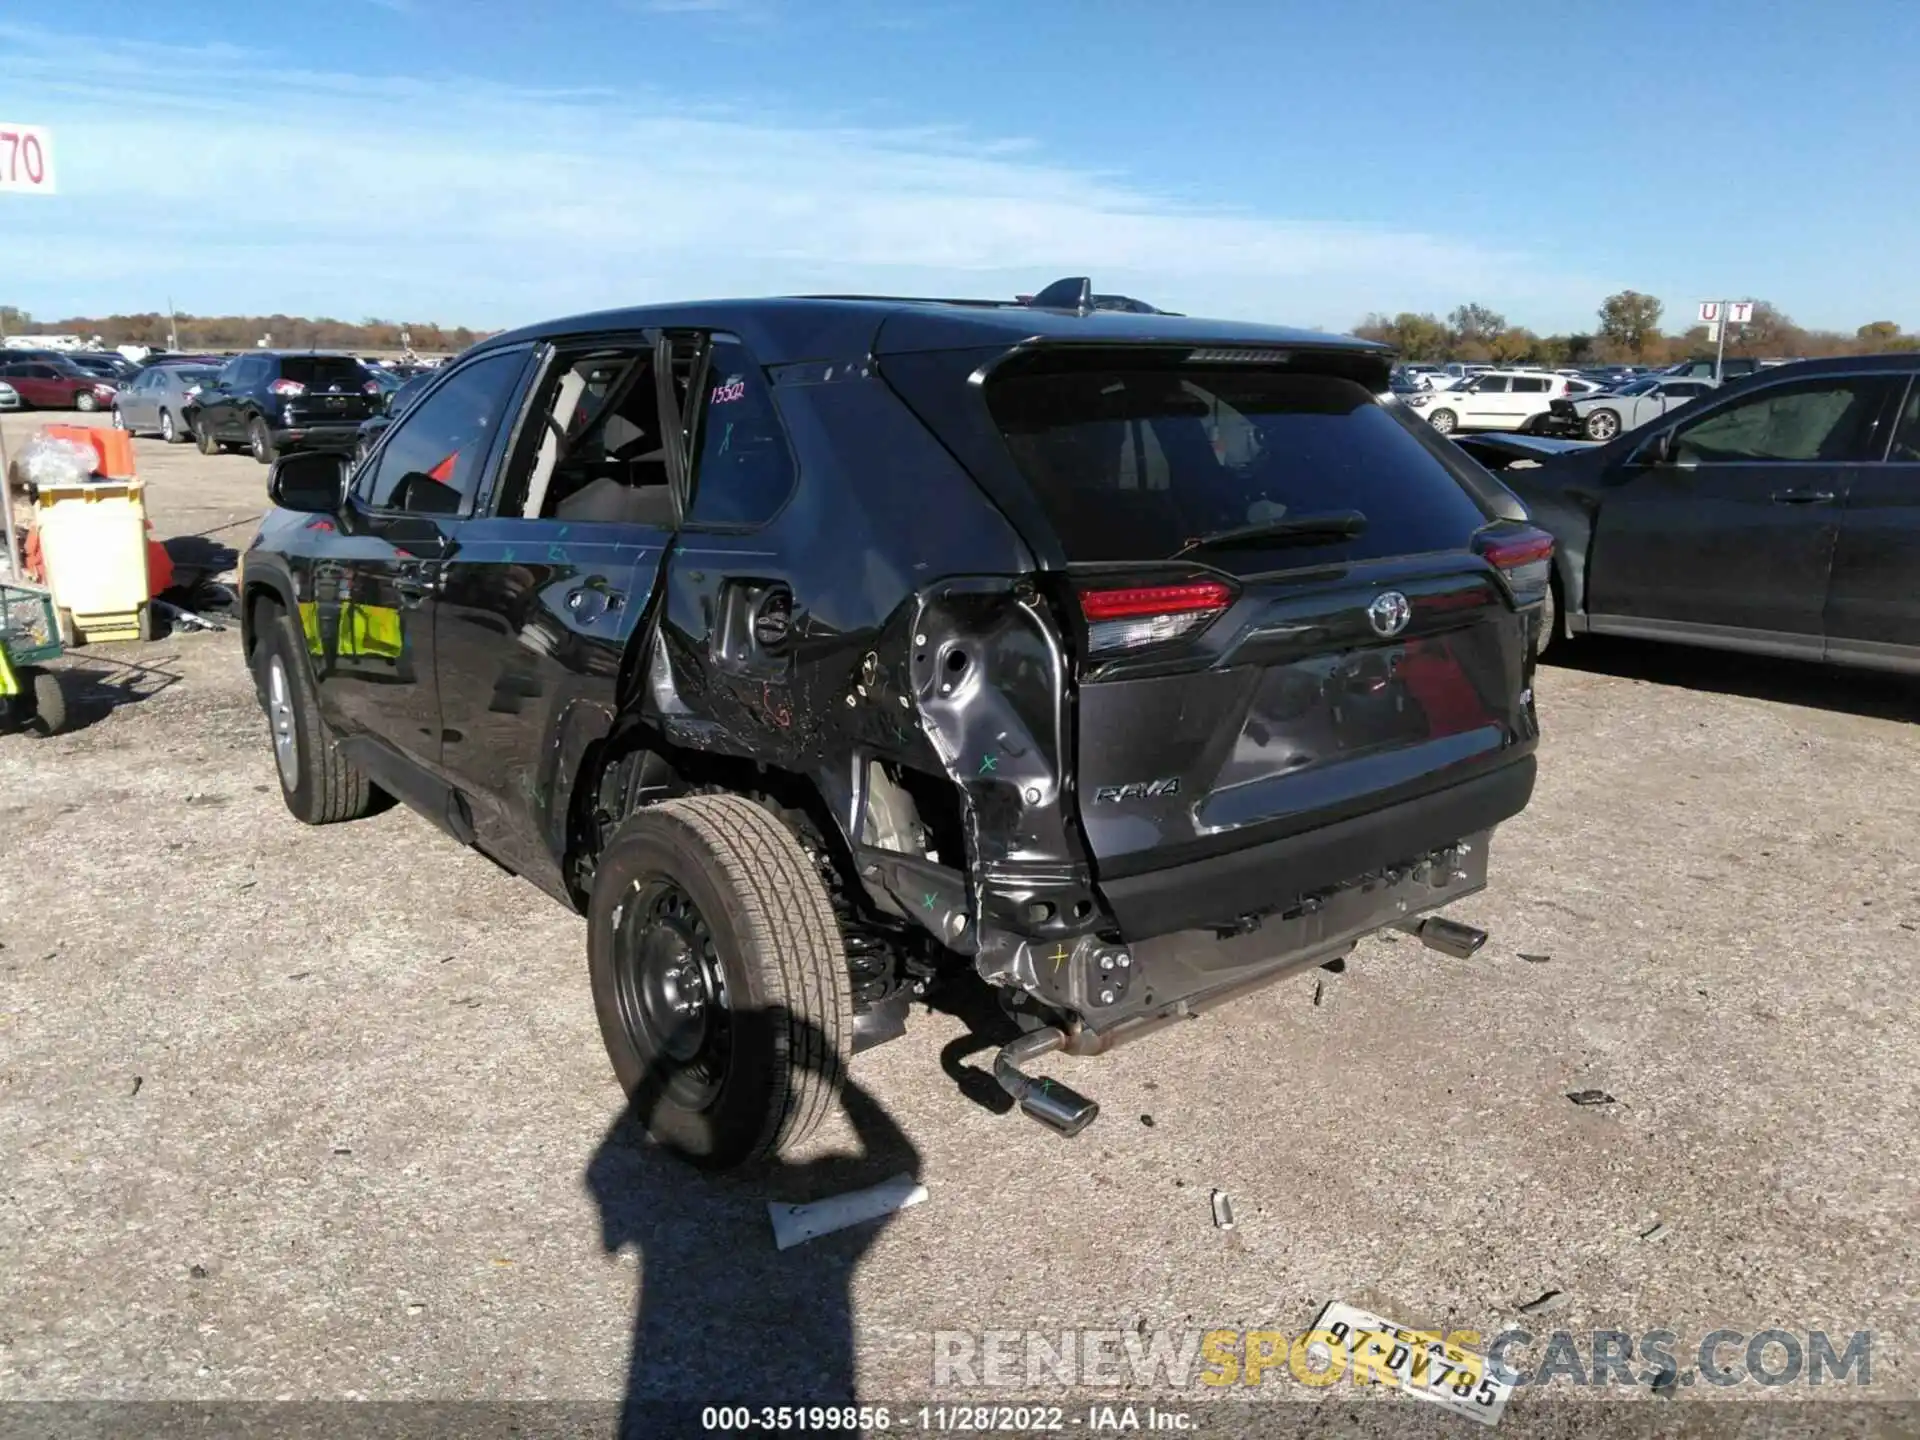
[987,351,1546,879]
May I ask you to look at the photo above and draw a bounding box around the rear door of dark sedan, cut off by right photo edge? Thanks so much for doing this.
[1826,376,1920,670]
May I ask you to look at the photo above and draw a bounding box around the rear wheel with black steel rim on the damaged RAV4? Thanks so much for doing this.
[588,795,852,1169]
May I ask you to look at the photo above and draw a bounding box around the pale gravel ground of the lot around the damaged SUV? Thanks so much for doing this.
[0,419,1920,1415]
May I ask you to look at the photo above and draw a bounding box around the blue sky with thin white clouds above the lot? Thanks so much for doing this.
[0,0,1920,332]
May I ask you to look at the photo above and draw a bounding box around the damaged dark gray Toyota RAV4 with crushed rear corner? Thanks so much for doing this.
[242,280,1551,1167]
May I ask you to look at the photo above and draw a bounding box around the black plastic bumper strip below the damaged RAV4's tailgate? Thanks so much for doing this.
[1100,753,1536,945]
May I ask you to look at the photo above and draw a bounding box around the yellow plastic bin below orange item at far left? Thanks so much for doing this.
[35,480,154,645]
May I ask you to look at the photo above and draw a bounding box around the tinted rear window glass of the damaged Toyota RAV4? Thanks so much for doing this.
[987,365,1486,564]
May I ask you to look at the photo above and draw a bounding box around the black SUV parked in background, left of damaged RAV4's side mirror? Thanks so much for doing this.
[184,349,380,465]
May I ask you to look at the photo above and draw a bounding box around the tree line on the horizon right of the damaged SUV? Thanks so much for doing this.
[1354,290,1920,365]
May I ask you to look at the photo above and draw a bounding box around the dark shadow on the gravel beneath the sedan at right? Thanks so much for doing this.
[1542,636,1920,720]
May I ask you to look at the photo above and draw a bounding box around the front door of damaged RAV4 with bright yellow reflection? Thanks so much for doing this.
[321,348,528,770]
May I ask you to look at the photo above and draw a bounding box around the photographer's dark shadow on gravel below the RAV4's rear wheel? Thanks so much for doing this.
[586,1013,920,1436]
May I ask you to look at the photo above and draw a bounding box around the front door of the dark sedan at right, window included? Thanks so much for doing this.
[1586,374,1889,659]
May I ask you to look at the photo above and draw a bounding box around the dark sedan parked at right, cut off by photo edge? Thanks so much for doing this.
[1500,355,1920,674]
